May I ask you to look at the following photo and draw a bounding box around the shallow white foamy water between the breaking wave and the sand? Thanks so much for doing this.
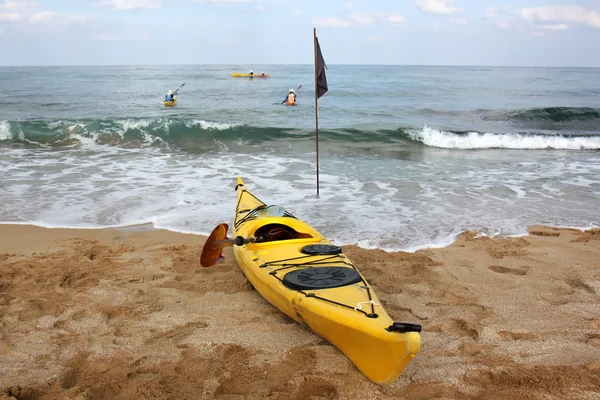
[0,138,600,251]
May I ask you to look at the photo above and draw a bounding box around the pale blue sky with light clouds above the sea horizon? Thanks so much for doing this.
[0,0,600,67]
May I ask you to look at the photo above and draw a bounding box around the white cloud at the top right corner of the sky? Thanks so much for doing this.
[519,6,600,30]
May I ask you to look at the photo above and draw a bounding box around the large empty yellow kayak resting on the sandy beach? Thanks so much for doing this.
[233,178,421,384]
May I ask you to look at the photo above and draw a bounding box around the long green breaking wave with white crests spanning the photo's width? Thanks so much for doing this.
[0,118,600,152]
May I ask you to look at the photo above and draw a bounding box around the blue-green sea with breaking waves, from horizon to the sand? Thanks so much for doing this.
[0,64,600,251]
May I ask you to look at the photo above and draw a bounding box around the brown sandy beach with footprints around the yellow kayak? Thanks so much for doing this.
[0,225,600,400]
